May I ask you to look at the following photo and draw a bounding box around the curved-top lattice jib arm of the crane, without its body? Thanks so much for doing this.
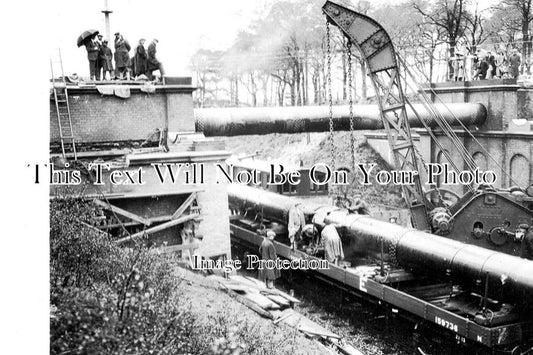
[322,1,434,230]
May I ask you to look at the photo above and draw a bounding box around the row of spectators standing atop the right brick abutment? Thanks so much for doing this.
[450,48,533,81]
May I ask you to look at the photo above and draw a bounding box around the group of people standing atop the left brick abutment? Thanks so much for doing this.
[85,32,165,80]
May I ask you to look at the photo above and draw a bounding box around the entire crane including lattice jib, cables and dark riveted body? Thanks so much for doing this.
[322,0,533,255]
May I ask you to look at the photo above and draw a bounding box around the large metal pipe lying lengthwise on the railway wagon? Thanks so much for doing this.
[228,185,533,300]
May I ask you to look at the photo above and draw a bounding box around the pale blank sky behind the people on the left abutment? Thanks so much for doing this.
[49,0,272,76]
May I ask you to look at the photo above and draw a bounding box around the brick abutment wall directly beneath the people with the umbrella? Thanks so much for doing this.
[50,86,194,143]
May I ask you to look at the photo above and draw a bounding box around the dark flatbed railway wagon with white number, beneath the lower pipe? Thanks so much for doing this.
[230,216,533,354]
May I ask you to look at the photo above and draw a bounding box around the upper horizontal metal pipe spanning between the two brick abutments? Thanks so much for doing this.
[194,103,487,136]
